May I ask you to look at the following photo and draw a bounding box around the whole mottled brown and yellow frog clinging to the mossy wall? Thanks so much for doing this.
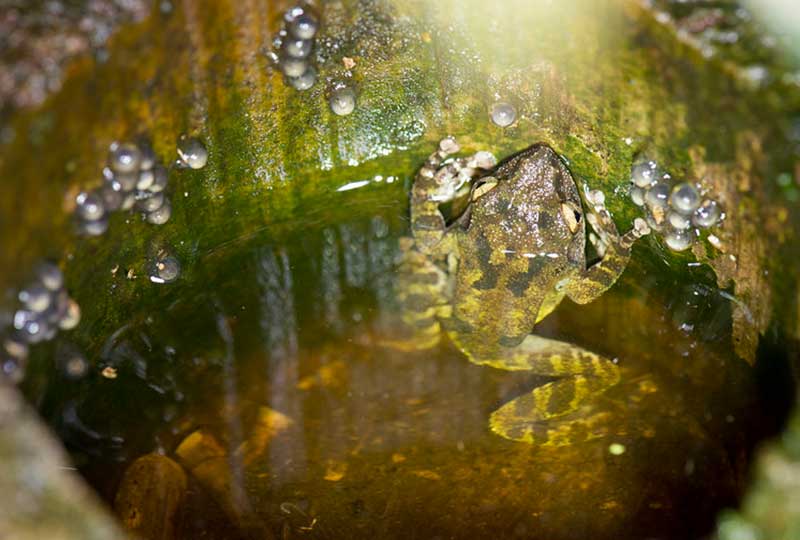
[393,138,649,445]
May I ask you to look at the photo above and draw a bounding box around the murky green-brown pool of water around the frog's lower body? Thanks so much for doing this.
[28,195,789,539]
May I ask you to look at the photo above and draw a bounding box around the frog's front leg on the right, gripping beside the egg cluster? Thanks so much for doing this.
[564,191,650,304]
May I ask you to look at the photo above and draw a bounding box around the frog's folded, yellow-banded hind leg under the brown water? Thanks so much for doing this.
[479,335,620,446]
